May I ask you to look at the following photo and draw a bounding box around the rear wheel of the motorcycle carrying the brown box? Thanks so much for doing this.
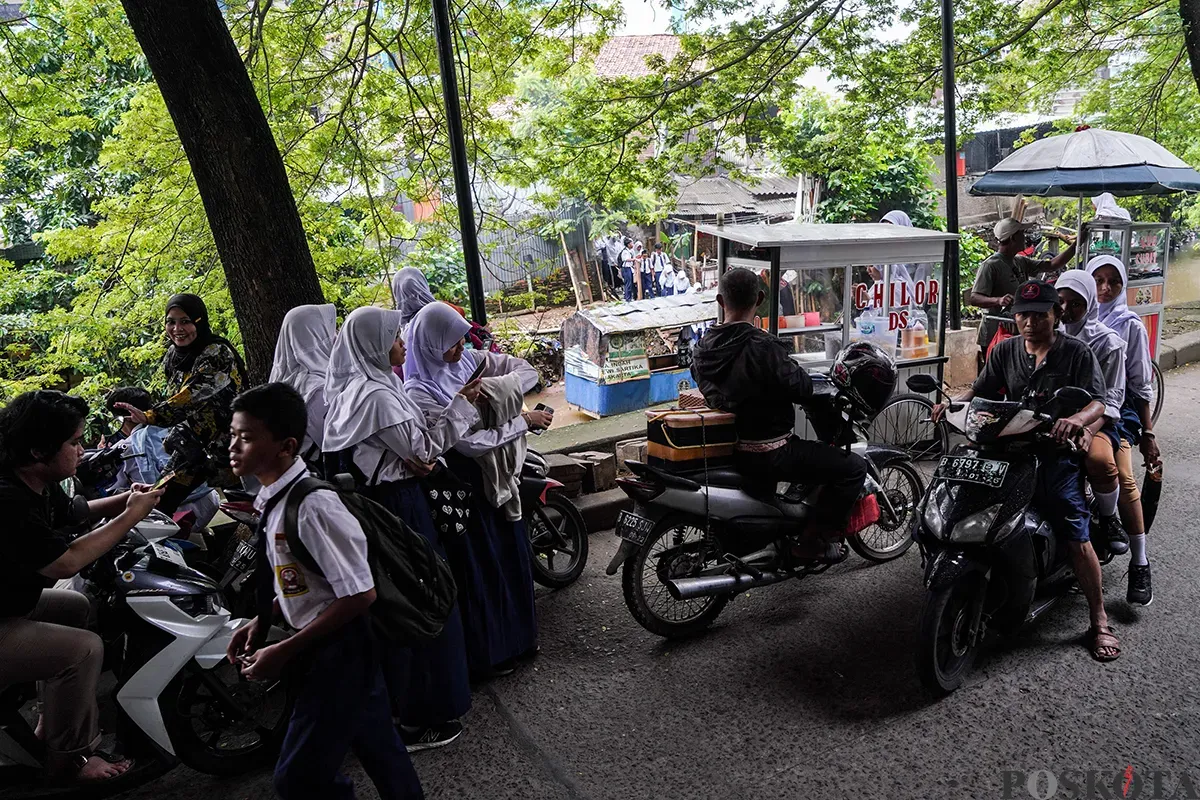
[620,517,732,639]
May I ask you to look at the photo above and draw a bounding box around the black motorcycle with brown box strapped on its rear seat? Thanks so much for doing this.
[607,366,924,638]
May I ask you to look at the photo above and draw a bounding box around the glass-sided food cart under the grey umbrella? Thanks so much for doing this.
[1079,219,1171,361]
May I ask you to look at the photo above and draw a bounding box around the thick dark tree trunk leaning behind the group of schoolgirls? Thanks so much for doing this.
[121,0,324,383]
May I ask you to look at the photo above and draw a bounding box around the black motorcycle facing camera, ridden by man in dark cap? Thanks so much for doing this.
[908,375,1091,696]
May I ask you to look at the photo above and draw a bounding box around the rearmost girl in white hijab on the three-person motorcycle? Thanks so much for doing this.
[1087,255,1160,606]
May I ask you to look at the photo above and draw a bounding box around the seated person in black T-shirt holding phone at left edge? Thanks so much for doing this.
[0,391,162,783]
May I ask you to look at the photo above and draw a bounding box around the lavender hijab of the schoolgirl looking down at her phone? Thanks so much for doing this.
[404,302,476,405]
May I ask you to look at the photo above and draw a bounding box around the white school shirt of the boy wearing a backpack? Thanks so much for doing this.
[254,458,374,630]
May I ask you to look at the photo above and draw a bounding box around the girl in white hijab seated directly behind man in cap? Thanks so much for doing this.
[1055,270,1126,554]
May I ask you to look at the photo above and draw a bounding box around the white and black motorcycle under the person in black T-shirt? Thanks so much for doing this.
[0,511,293,798]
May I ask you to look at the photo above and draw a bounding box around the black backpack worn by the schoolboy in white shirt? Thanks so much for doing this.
[283,477,458,644]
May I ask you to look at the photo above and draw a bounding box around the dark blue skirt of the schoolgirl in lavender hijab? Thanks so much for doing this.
[444,452,538,674]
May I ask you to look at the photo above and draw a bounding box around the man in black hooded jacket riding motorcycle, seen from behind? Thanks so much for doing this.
[691,269,866,554]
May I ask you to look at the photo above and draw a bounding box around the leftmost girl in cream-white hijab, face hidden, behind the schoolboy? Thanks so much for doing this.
[271,303,337,464]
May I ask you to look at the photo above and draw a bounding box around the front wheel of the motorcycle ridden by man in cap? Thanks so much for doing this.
[917,576,983,697]
